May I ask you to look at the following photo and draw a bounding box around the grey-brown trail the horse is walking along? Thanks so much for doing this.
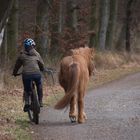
[33,73,140,140]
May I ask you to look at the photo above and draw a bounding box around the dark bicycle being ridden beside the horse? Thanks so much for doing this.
[16,73,40,124]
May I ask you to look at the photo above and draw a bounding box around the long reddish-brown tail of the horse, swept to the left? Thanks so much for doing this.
[55,63,79,109]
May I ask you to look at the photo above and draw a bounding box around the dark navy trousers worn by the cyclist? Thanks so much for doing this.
[22,74,43,103]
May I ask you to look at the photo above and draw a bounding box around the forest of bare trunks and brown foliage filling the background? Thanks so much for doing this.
[0,0,140,65]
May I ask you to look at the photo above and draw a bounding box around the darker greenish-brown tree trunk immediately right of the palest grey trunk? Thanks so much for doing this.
[106,0,117,50]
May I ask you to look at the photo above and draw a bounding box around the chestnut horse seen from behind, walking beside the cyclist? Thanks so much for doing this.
[55,47,94,123]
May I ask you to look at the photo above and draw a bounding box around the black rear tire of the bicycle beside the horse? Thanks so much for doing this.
[32,90,40,124]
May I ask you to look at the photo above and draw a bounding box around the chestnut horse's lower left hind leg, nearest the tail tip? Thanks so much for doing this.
[69,96,77,123]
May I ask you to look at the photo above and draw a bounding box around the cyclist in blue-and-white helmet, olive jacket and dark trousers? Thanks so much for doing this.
[13,38,44,112]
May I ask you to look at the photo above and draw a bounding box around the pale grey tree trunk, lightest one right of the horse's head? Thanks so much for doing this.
[99,0,110,50]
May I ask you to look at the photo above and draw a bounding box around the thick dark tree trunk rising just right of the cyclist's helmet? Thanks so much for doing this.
[35,0,49,57]
